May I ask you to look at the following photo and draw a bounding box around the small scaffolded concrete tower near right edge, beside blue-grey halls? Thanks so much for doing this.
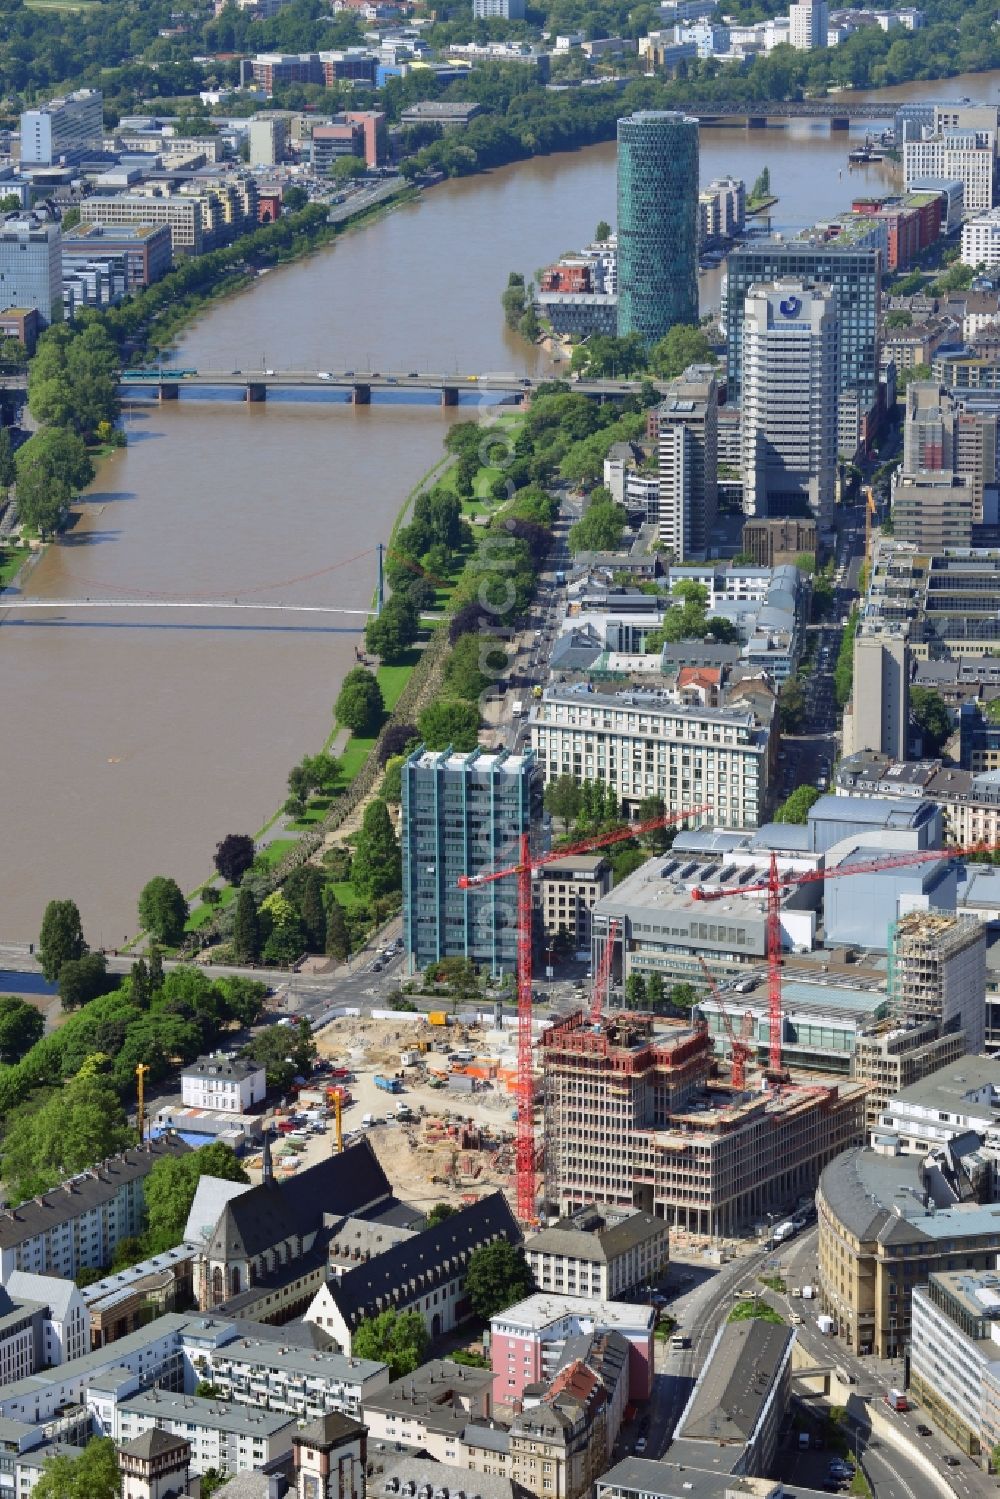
[889,911,987,1054]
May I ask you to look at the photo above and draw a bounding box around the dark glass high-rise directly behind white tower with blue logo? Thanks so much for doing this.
[726,240,882,437]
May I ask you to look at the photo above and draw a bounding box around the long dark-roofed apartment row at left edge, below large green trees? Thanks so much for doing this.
[0,1135,190,1285]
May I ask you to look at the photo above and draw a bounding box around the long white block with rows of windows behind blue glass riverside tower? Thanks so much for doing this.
[531,685,769,827]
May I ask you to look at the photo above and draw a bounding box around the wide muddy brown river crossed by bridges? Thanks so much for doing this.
[0,73,1000,946]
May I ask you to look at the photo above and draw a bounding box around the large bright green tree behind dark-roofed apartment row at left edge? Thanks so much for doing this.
[1,1057,133,1202]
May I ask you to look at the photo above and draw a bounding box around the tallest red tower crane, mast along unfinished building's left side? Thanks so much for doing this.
[459,805,712,1223]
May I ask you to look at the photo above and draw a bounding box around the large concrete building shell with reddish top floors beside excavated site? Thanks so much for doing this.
[541,1015,865,1237]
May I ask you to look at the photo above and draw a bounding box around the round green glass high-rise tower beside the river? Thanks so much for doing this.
[618,109,699,345]
